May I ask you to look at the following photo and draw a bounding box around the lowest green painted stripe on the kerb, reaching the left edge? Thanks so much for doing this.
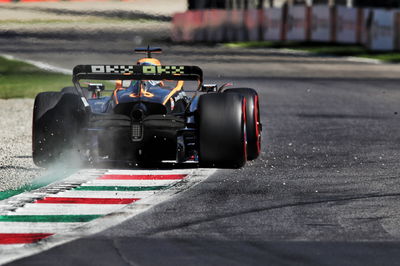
[0,215,103,223]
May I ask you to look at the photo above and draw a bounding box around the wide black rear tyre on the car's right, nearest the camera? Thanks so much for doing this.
[197,93,247,168]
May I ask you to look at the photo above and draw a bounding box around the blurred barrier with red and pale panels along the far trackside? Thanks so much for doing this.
[172,5,400,51]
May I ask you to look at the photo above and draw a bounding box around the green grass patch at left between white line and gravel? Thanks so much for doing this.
[0,57,72,99]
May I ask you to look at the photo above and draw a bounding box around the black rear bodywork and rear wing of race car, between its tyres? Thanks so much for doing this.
[73,65,202,162]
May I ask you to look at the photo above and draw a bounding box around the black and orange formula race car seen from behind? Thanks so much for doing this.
[32,47,262,168]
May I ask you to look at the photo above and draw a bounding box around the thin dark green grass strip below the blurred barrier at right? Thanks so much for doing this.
[225,41,400,63]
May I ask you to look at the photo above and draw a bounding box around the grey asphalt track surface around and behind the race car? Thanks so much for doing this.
[0,30,400,265]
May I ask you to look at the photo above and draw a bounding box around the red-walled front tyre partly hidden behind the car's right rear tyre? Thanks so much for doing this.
[224,88,261,160]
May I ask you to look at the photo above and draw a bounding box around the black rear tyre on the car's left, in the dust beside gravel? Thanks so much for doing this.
[32,92,85,167]
